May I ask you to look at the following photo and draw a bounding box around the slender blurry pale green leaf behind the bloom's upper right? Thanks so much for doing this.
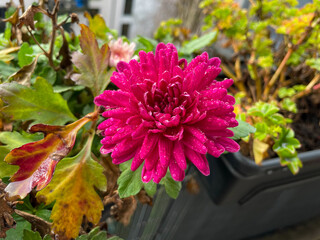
[179,31,218,55]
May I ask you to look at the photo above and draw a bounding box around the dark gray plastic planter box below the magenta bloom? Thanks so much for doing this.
[111,150,320,240]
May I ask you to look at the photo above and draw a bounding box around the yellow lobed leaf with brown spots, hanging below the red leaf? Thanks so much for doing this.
[37,135,106,239]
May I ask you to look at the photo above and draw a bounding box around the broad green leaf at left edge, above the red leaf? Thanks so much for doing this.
[0,77,76,125]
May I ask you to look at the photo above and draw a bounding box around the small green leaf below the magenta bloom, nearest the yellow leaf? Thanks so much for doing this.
[117,161,143,198]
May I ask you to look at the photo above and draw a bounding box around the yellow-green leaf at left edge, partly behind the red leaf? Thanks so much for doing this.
[0,132,39,178]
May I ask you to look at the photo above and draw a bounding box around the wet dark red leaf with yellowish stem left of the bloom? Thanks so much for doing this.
[5,112,97,198]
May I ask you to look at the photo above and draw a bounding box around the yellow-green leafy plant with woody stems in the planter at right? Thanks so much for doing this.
[200,0,320,171]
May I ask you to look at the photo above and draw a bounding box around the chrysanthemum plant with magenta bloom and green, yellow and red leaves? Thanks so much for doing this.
[0,0,252,240]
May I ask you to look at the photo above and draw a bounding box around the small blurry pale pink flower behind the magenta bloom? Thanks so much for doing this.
[108,38,136,67]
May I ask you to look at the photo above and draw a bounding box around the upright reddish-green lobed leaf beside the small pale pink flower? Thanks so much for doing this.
[71,24,113,96]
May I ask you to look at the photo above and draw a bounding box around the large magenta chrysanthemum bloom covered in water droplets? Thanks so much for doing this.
[95,43,239,183]
